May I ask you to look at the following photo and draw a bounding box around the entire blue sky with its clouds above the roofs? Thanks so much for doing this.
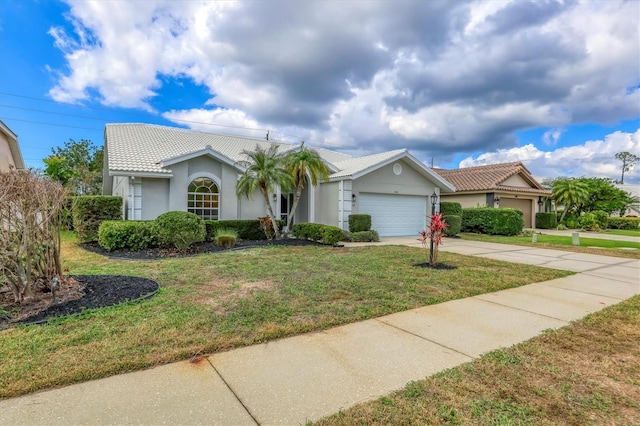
[0,0,640,183]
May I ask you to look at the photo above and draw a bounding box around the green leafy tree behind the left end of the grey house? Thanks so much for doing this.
[43,139,104,195]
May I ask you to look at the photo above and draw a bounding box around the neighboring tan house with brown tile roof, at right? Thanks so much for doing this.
[433,161,551,228]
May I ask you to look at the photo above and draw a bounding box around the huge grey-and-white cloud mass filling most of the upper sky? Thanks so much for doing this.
[49,0,640,161]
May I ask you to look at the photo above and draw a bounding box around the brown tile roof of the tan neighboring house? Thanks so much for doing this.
[433,161,551,195]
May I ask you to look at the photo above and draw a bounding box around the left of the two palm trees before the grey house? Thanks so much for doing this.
[236,144,293,239]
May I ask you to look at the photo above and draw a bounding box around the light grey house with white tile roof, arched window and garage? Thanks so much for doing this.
[103,123,455,236]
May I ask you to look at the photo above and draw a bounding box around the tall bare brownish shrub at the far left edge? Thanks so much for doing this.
[0,170,67,302]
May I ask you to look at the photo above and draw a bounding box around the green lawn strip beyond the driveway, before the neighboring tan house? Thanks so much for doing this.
[460,235,640,259]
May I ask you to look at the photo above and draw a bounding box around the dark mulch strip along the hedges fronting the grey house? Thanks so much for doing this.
[80,238,322,260]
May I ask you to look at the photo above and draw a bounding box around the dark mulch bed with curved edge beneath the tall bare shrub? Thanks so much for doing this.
[0,275,159,328]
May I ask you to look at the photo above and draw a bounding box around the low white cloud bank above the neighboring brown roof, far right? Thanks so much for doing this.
[460,129,640,183]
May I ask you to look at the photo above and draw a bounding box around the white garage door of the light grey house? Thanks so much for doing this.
[358,194,427,237]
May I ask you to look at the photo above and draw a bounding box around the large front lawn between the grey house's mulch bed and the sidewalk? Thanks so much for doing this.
[0,234,571,398]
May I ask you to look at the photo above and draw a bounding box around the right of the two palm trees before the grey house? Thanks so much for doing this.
[285,141,329,230]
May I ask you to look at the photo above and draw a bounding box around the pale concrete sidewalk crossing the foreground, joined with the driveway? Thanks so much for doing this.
[0,237,640,425]
